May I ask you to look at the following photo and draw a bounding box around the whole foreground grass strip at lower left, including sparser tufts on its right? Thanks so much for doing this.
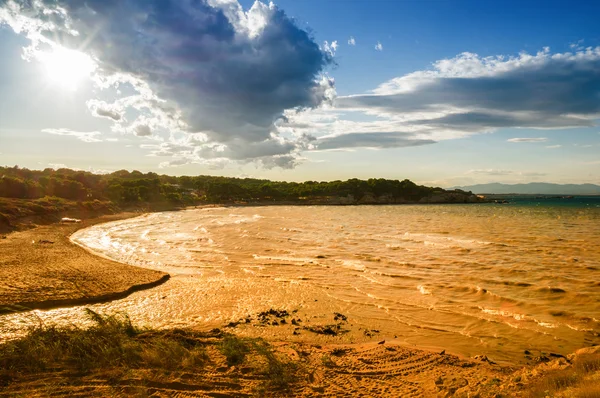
[0,309,303,395]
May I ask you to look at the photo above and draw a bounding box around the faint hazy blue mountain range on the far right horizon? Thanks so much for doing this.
[453,182,600,195]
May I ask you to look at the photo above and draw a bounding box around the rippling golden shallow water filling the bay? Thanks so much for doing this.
[0,204,600,363]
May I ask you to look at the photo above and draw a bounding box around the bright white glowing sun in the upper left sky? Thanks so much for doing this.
[38,47,96,90]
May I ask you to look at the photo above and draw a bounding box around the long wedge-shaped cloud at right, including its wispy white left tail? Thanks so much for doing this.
[278,48,600,150]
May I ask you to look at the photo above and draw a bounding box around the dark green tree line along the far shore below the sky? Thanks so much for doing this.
[0,166,444,205]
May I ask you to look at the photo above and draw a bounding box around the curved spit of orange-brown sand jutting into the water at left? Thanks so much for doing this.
[0,213,169,314]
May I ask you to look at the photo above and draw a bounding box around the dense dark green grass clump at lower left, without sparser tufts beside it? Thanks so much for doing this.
[0,309,211,377]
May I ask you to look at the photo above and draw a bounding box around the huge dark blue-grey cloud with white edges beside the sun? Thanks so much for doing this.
[0,0,337,167]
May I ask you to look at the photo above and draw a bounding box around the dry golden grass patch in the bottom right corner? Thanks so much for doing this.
[529,354,600,398]
